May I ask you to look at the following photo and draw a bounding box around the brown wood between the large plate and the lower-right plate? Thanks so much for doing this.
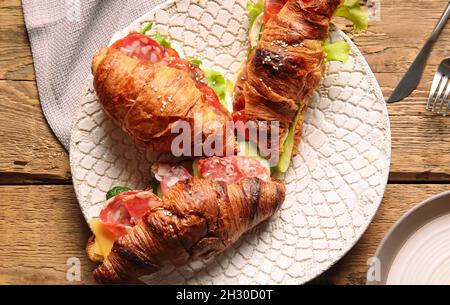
[313,184,449,285]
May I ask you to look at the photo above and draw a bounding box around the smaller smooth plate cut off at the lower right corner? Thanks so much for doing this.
[368,191,450,285]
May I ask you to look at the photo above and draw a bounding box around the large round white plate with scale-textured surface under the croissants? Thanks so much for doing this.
[70,0,391,284]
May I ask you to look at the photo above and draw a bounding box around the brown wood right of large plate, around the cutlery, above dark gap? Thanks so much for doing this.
[353,0,450,181]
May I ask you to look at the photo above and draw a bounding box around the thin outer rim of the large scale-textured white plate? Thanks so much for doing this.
[70,0,391,283]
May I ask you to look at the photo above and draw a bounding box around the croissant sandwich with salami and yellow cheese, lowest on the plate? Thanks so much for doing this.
[87,156,285,283]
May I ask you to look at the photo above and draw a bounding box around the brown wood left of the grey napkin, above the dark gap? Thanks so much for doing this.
[0,0,70,184]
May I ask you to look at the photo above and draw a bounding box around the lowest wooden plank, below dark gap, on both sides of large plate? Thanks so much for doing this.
[0,184,448,284]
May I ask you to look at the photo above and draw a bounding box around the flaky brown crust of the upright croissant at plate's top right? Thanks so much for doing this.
[235,0,342,149]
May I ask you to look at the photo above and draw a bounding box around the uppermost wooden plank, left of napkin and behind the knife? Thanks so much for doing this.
[0,0,450,80]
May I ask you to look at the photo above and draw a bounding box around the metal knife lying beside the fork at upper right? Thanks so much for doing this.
[388,1,450,103]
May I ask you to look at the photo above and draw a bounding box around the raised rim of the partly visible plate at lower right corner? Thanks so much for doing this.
[366,191,450,285]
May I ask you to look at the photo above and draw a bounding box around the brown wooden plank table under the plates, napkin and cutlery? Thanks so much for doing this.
[0,0,450,284]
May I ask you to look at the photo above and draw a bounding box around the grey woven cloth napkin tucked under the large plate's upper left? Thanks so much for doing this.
[22,0,165,150]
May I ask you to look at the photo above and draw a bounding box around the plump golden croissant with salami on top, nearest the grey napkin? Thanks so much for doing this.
[92,33,234,155]
